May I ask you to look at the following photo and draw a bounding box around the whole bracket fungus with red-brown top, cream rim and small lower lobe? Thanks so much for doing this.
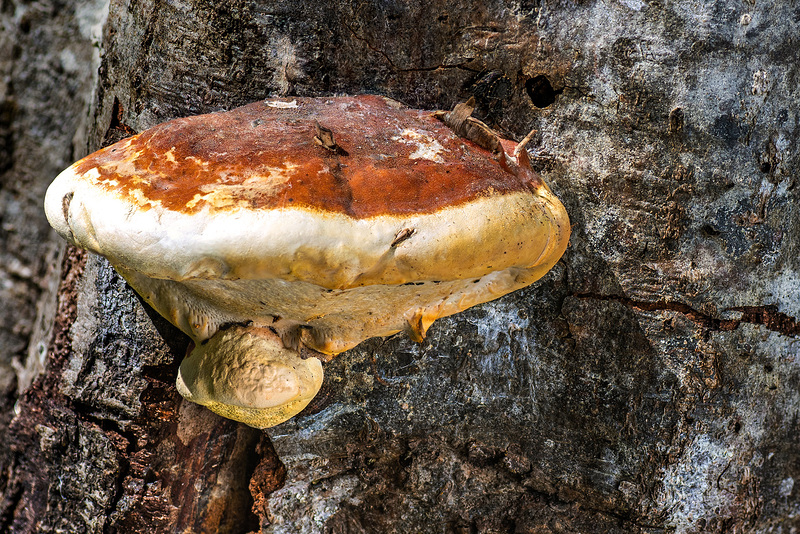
[45,95,570,428]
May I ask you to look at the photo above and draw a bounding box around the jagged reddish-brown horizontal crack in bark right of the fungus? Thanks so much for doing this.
[573,293,800,337]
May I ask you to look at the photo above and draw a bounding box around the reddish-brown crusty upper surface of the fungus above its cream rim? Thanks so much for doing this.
[67,95,541,219]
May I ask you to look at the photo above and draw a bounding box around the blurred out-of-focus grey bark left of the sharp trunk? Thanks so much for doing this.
[0,0,108,429]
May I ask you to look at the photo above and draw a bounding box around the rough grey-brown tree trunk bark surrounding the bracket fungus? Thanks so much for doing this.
[0,0,800,533]
